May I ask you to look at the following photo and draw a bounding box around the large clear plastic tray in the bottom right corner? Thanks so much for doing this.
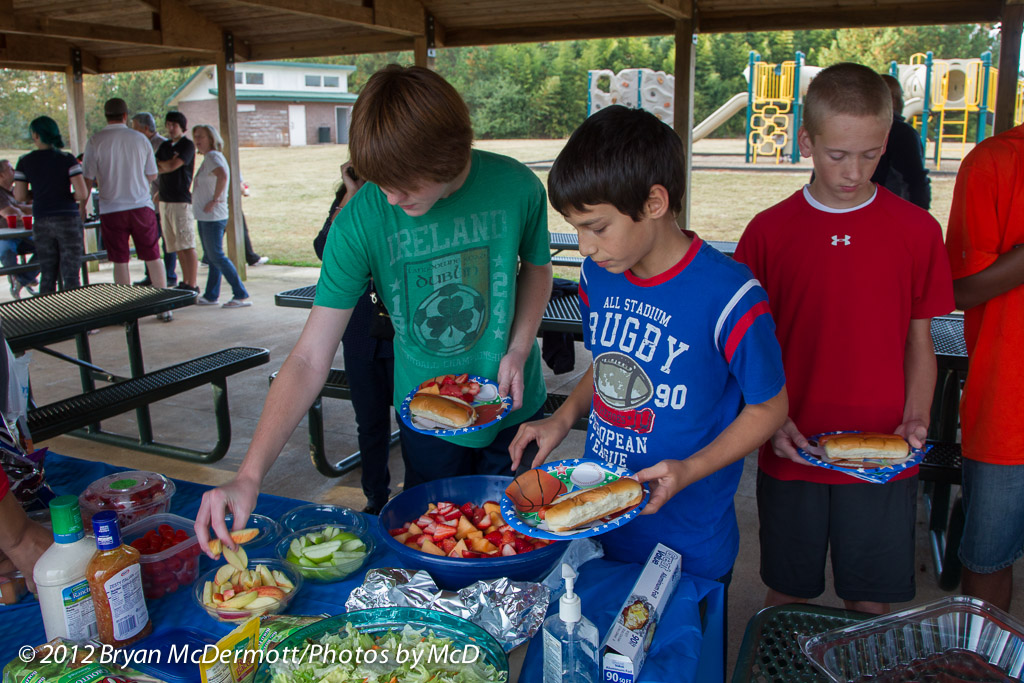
[798,595,1024,683]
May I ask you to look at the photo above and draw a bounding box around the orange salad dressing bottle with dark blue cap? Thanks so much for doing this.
[86,510,153,647]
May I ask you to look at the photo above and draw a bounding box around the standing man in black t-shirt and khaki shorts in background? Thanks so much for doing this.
[157,112,199,294]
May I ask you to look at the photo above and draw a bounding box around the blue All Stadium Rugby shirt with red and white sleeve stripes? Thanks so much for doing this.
[580,232,785,579]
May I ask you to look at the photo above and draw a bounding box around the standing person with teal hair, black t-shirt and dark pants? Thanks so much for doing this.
[14,116,89,294]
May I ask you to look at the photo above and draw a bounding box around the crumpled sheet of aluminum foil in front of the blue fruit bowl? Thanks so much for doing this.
[345,567,550,652]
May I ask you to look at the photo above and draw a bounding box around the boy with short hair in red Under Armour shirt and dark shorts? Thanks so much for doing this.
[736,63,953,613]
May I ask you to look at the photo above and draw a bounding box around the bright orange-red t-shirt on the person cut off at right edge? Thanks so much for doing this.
[946,126,1024,465]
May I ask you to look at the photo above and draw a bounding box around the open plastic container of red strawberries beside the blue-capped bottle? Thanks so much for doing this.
[122,512,200,600]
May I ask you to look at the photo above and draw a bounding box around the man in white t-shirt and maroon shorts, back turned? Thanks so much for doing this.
[83,97,171,299]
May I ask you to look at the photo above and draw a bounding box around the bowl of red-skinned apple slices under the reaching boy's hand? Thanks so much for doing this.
[193,547,302,623]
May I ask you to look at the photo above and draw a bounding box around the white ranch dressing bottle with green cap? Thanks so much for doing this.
[32,496,96,640]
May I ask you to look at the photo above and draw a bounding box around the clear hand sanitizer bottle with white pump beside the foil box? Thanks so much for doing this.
[544,563,600,683]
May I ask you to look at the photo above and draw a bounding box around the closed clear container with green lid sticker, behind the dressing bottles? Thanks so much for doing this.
[79,470,174,528]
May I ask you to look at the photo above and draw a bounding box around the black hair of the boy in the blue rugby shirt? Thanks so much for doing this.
[548,104,686,221]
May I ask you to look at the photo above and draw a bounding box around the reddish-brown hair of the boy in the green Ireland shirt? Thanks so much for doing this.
[348,65,473,189]
